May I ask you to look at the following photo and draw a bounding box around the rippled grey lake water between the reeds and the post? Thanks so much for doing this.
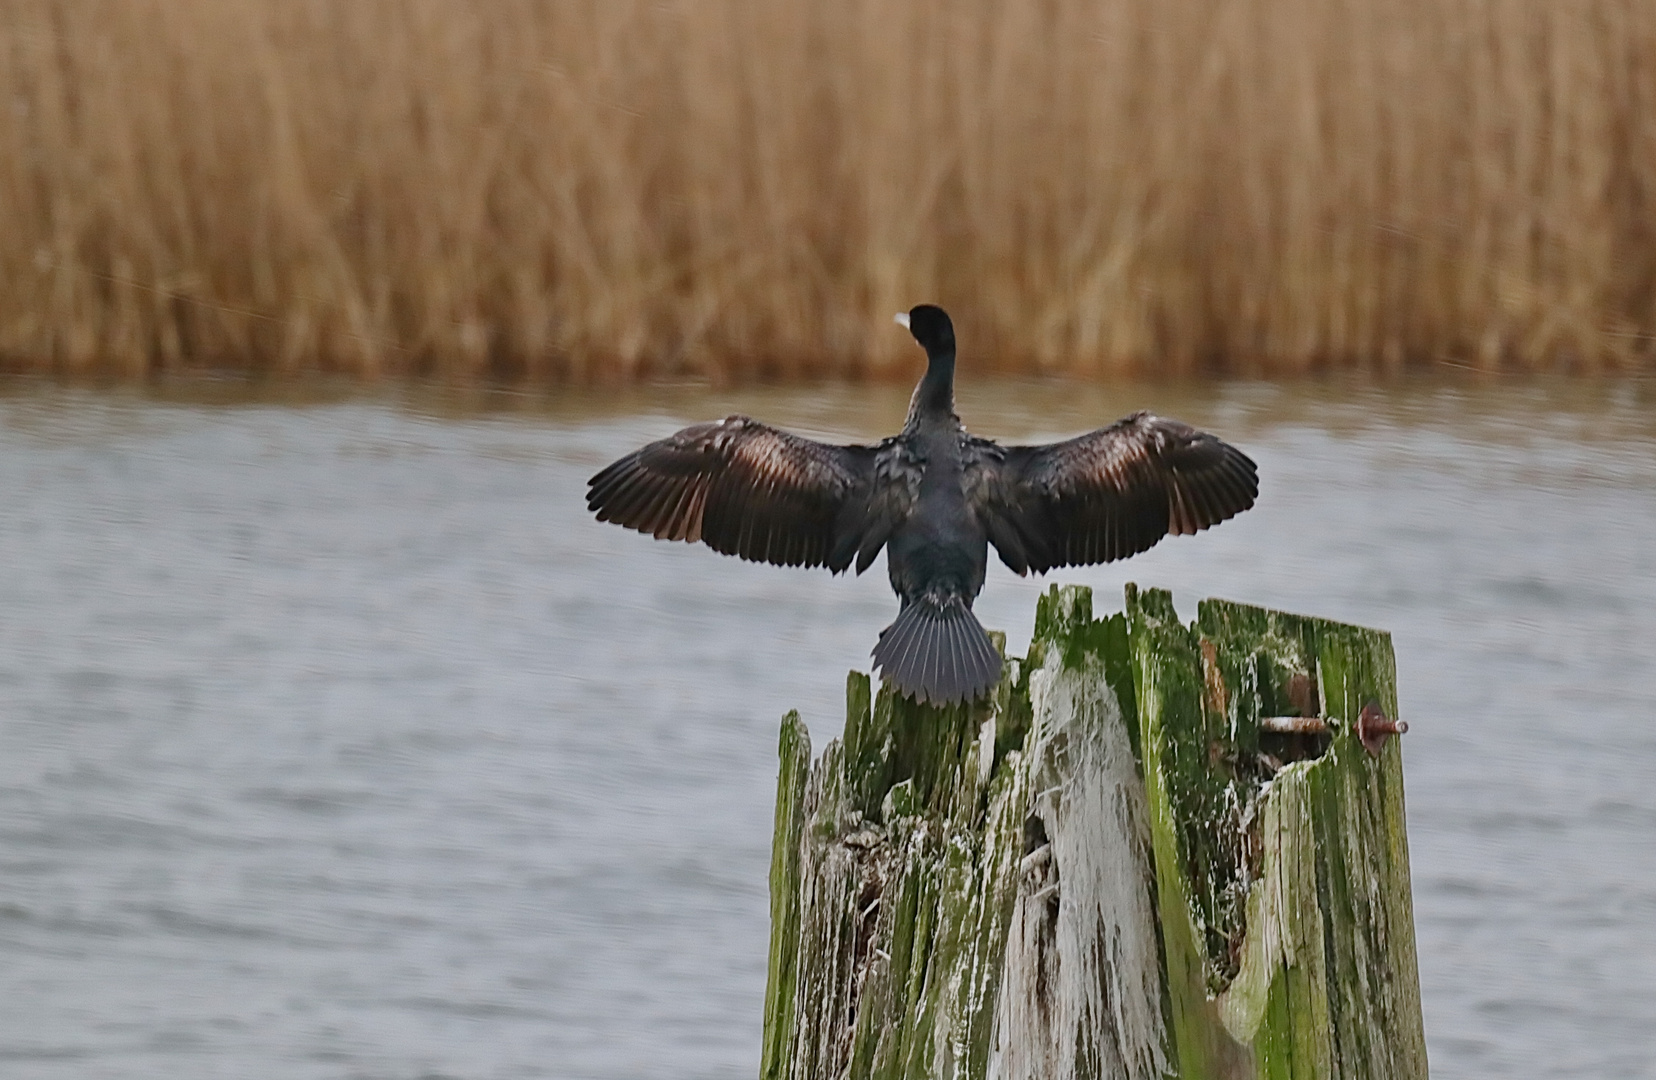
[0,372,1656,1080]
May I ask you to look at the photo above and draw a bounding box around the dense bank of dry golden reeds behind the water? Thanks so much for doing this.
[0,0,1656,381]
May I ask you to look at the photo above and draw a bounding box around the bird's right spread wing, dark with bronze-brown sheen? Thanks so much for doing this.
[965,412,1259,573]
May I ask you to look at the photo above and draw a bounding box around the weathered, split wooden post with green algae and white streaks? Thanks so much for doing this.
[760,586,1426,1080]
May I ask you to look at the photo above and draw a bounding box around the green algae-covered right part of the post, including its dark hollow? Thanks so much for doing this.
[1128,588,1426,1080]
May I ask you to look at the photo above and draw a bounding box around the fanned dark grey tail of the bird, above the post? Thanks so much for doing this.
[874,596,1000,706]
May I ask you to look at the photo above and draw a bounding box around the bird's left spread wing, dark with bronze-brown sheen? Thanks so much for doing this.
[586,416,878,573]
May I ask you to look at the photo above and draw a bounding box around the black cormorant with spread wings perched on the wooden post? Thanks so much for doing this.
[586,305,1259,704]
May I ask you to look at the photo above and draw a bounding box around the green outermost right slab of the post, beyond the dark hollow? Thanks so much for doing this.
[1197,601,1426,1078]
